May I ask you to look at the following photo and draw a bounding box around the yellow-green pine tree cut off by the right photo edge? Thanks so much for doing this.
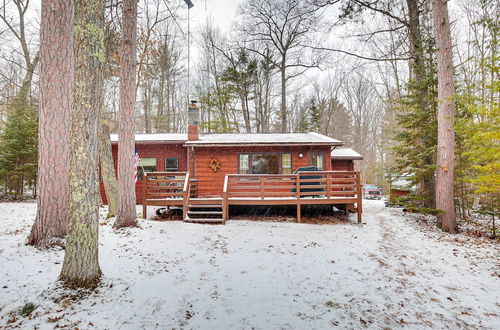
[455,9,500,237]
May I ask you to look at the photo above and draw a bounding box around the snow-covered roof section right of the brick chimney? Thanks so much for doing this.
[186,132,342,145]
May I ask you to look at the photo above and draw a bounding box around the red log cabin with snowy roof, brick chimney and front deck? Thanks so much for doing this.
[100,102,362,222]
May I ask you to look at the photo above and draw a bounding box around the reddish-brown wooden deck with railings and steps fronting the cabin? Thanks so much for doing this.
[143,171,362,223]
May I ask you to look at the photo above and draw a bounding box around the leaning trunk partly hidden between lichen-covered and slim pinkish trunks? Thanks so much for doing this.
[99,114,118,218]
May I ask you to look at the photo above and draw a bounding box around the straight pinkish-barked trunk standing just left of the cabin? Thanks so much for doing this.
[115,0,137,228]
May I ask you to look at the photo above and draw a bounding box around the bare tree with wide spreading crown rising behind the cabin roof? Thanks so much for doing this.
[241,0,321,132]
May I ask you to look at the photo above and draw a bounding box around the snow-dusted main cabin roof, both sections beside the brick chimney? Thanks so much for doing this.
[111,132,342,146]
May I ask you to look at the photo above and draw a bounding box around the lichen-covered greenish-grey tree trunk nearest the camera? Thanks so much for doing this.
[59,0,105,289]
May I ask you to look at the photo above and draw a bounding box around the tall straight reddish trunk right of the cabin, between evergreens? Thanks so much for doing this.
[432,0,457,232]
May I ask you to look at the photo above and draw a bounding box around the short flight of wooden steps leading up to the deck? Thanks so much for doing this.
[184,198,225,224]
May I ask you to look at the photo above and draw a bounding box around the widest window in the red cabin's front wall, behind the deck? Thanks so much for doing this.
[238,152,292,174]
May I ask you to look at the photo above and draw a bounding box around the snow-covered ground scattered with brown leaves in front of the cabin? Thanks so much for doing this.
[0,201,500,329]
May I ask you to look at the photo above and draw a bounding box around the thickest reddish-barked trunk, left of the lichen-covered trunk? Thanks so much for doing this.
[28,0,74,247]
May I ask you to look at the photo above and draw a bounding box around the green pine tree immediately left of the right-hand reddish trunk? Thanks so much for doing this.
[389,12,437,213]
